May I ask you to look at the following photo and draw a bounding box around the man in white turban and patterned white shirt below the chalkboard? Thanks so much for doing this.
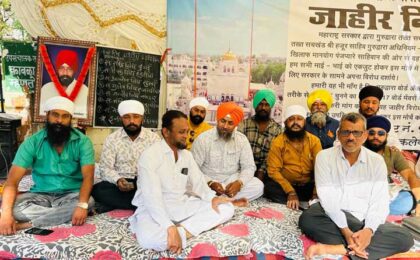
[92,100,160,213]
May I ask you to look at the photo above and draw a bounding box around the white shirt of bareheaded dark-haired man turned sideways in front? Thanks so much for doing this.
[132,140,215,229]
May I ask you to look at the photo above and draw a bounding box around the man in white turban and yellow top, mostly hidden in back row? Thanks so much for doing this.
[187,97,212,150]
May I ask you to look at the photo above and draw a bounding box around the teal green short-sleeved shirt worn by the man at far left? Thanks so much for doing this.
[13,129,95,193]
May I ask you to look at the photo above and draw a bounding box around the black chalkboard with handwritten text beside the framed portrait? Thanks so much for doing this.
[95,47,160,128]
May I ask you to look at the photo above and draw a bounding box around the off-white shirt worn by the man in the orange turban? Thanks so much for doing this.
[191,128,256,184]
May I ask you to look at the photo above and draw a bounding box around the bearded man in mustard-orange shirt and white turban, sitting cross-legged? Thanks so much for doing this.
[264,105,322,210]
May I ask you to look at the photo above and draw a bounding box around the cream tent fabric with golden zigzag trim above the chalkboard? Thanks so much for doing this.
[11,0,166,54]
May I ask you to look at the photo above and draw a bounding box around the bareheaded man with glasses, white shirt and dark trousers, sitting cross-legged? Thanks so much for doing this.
[299,113,414,259]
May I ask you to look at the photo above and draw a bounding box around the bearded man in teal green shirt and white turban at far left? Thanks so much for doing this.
[0,96,95,235]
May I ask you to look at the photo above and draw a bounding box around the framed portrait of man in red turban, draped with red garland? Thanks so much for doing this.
[34,37,96,126]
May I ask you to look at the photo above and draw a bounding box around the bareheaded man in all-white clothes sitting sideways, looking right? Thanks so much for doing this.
[129,110,234,254]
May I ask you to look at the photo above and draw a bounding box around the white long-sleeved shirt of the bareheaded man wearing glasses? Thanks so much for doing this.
[315,145,389,232]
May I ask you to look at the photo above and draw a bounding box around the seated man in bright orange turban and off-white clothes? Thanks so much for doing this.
[192,102,264,200]
